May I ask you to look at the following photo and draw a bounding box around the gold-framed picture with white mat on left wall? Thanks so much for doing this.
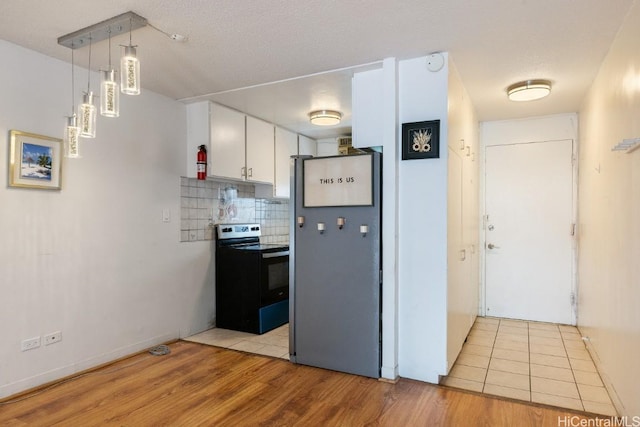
[9,130,62,190]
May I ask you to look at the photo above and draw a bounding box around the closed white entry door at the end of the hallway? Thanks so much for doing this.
[485,140,575,324]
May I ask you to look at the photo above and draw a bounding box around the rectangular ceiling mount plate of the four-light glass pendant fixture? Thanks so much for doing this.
[58,12,148,49]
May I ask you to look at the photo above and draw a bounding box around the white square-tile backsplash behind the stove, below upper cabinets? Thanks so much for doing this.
[180,177,289,243]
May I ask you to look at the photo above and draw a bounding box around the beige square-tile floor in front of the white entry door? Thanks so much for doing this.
[442,317,617,416]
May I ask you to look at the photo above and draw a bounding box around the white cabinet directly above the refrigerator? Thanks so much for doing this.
[351,69,384,148]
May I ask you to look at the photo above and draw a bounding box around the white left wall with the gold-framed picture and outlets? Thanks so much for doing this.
[0,41,213,398]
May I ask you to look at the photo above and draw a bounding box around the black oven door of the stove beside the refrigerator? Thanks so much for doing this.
[260,249,289,307]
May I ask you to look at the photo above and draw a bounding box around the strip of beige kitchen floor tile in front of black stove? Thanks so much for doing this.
[184,324,289,360]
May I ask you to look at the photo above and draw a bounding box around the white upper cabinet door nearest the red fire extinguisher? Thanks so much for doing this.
[208,104,246,179]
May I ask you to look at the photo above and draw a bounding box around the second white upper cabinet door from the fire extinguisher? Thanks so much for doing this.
[246,116,275,184]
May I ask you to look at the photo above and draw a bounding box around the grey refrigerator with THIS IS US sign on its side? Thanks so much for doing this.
[289,152,382,378]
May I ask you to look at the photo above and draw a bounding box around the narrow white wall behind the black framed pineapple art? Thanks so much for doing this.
[398,53,448,383]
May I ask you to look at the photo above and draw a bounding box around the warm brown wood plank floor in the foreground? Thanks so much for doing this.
[0,341,604,427]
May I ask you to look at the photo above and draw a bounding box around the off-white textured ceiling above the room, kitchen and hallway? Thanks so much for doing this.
[0,0,634,137]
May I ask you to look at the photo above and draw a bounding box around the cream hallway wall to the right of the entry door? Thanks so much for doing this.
[578,3,640,416]
